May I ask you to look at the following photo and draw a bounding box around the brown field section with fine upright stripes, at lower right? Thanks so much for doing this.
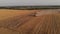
[32,15,60,34]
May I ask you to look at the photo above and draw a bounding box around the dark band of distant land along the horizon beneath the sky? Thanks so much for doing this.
[0,5,60,10]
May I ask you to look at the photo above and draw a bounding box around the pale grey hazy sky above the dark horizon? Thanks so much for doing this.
[0,0,60,6]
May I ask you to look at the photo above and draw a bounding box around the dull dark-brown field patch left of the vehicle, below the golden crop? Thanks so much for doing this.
[0,16,32,29]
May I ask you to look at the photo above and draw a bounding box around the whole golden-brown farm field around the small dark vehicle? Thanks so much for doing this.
[0,9,60,34]
